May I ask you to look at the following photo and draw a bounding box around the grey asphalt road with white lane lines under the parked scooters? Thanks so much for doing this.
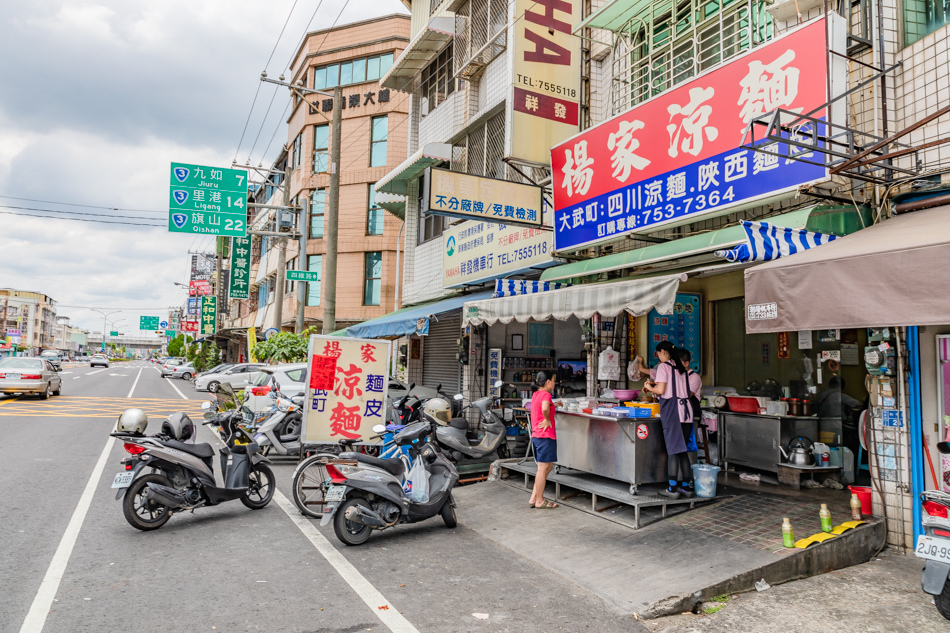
[0,362,646,633]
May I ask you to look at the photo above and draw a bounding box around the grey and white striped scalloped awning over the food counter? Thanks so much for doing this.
[462,275,685,325]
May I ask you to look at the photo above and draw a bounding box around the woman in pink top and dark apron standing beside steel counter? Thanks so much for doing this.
[643,341,693,499]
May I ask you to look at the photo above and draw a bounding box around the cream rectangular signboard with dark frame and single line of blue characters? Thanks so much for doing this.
[423,167,542,226]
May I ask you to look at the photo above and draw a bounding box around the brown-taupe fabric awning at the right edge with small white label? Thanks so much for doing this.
[745,206,950,334]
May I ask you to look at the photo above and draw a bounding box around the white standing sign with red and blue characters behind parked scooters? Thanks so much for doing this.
[302,334,392,444]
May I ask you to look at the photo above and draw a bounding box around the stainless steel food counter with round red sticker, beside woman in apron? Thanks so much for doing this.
[554,411,666,494]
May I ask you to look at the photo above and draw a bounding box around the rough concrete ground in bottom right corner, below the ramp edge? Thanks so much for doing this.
[645,552,950,633]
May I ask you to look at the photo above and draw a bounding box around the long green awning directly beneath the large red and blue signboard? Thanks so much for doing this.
[541,205,871,281]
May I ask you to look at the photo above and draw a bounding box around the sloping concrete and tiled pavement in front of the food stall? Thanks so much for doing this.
[454,478,883,618]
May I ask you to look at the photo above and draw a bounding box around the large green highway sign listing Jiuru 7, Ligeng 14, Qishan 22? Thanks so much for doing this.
[168,163,247,237]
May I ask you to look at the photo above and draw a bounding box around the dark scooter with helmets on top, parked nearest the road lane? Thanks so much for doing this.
[111,402,276,531]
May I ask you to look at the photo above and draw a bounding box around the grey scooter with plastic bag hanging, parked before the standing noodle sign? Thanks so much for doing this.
[320,419,459,545]
